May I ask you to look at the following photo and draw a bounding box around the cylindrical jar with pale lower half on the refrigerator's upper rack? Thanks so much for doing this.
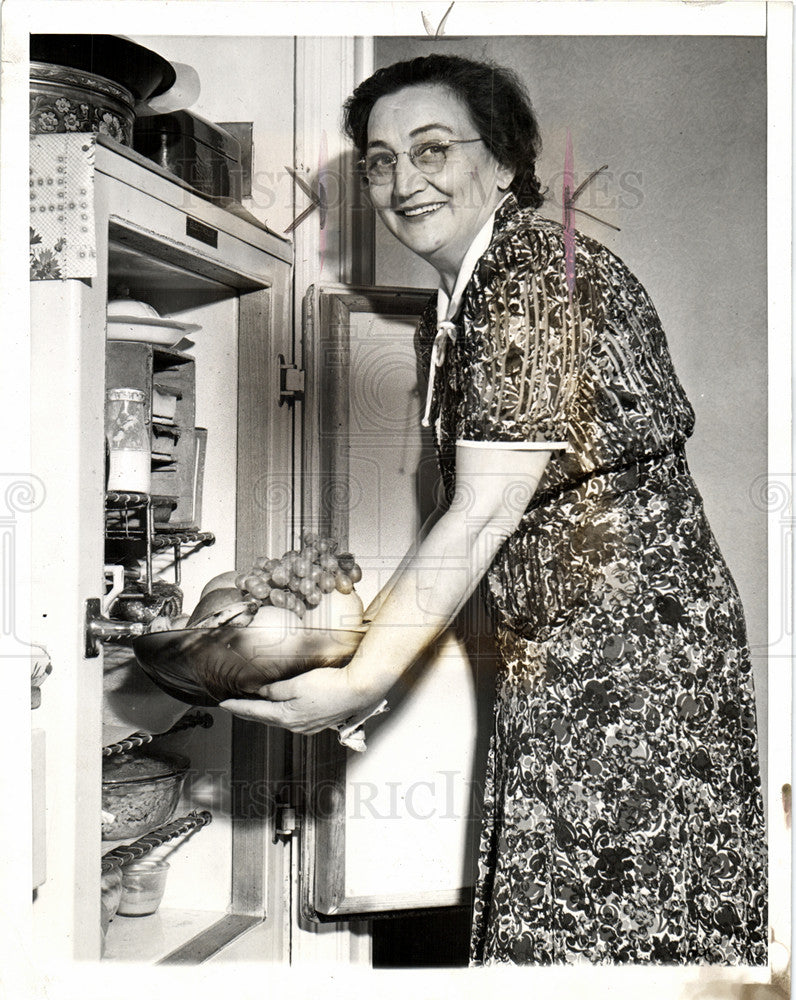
[105,387,152,493]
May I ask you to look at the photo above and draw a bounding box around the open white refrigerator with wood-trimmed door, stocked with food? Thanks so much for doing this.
[30,127,491,965]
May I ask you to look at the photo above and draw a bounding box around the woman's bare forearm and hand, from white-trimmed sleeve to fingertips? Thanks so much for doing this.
[222,445,550,733]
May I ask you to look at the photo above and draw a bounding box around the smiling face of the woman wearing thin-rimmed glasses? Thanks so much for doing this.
[368,84,513,291]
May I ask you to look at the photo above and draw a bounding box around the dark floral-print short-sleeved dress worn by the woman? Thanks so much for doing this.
[416,191,767,965]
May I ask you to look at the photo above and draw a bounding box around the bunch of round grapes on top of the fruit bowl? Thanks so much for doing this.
[235,531,362,618]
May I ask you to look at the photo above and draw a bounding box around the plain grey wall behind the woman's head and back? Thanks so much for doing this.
[375,36,768,780]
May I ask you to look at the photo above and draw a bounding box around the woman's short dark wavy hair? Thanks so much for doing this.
[343,53,544,208]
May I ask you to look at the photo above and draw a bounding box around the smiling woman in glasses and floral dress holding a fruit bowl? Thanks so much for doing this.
[221,50,767,965]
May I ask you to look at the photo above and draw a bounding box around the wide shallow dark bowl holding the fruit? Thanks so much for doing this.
[133,623,365,706]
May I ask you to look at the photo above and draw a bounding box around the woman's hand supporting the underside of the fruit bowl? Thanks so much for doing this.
[220,667,382,735]
